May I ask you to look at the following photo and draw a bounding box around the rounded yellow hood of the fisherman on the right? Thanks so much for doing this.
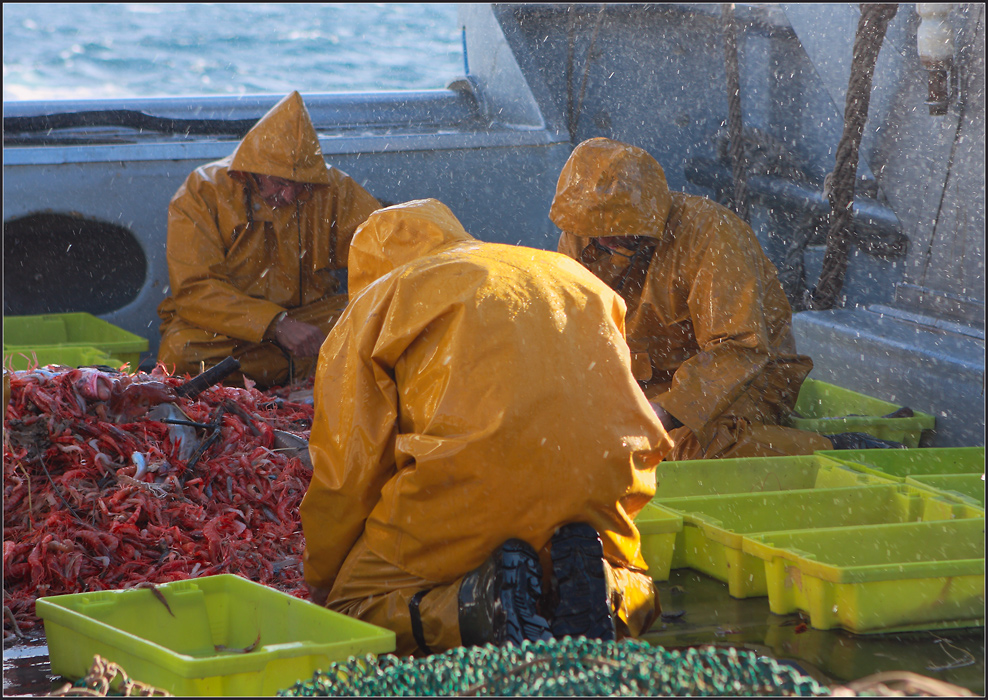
[549,138,672,238]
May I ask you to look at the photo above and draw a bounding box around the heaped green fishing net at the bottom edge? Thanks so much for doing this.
[279,637,830,697]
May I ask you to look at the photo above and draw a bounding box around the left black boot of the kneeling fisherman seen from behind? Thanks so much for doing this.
[459,539,552,646]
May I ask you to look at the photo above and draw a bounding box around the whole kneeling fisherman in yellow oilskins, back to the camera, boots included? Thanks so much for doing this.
[301,199,671,654]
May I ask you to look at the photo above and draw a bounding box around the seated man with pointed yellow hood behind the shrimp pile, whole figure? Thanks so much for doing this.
[158,92,380,388]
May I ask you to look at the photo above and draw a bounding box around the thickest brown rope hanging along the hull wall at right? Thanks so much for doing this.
[806,3,899,310]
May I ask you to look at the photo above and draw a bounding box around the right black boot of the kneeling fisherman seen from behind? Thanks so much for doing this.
[551,523,614,641]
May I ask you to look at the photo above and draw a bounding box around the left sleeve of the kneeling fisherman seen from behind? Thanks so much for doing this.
[299,290,398,588]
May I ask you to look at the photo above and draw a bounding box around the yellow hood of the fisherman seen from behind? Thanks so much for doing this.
[347,199,475,297]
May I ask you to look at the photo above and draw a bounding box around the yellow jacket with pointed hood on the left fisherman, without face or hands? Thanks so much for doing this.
[158,92,380,343]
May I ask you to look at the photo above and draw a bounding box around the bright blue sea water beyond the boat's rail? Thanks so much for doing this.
[3,3,464,101]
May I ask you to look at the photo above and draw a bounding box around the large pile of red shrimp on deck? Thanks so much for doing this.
[3,365,313,641]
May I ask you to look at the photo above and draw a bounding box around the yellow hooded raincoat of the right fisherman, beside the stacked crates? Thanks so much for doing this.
[549,138,831,459]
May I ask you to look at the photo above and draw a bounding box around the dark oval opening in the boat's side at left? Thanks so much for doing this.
[3,213,147,316]
